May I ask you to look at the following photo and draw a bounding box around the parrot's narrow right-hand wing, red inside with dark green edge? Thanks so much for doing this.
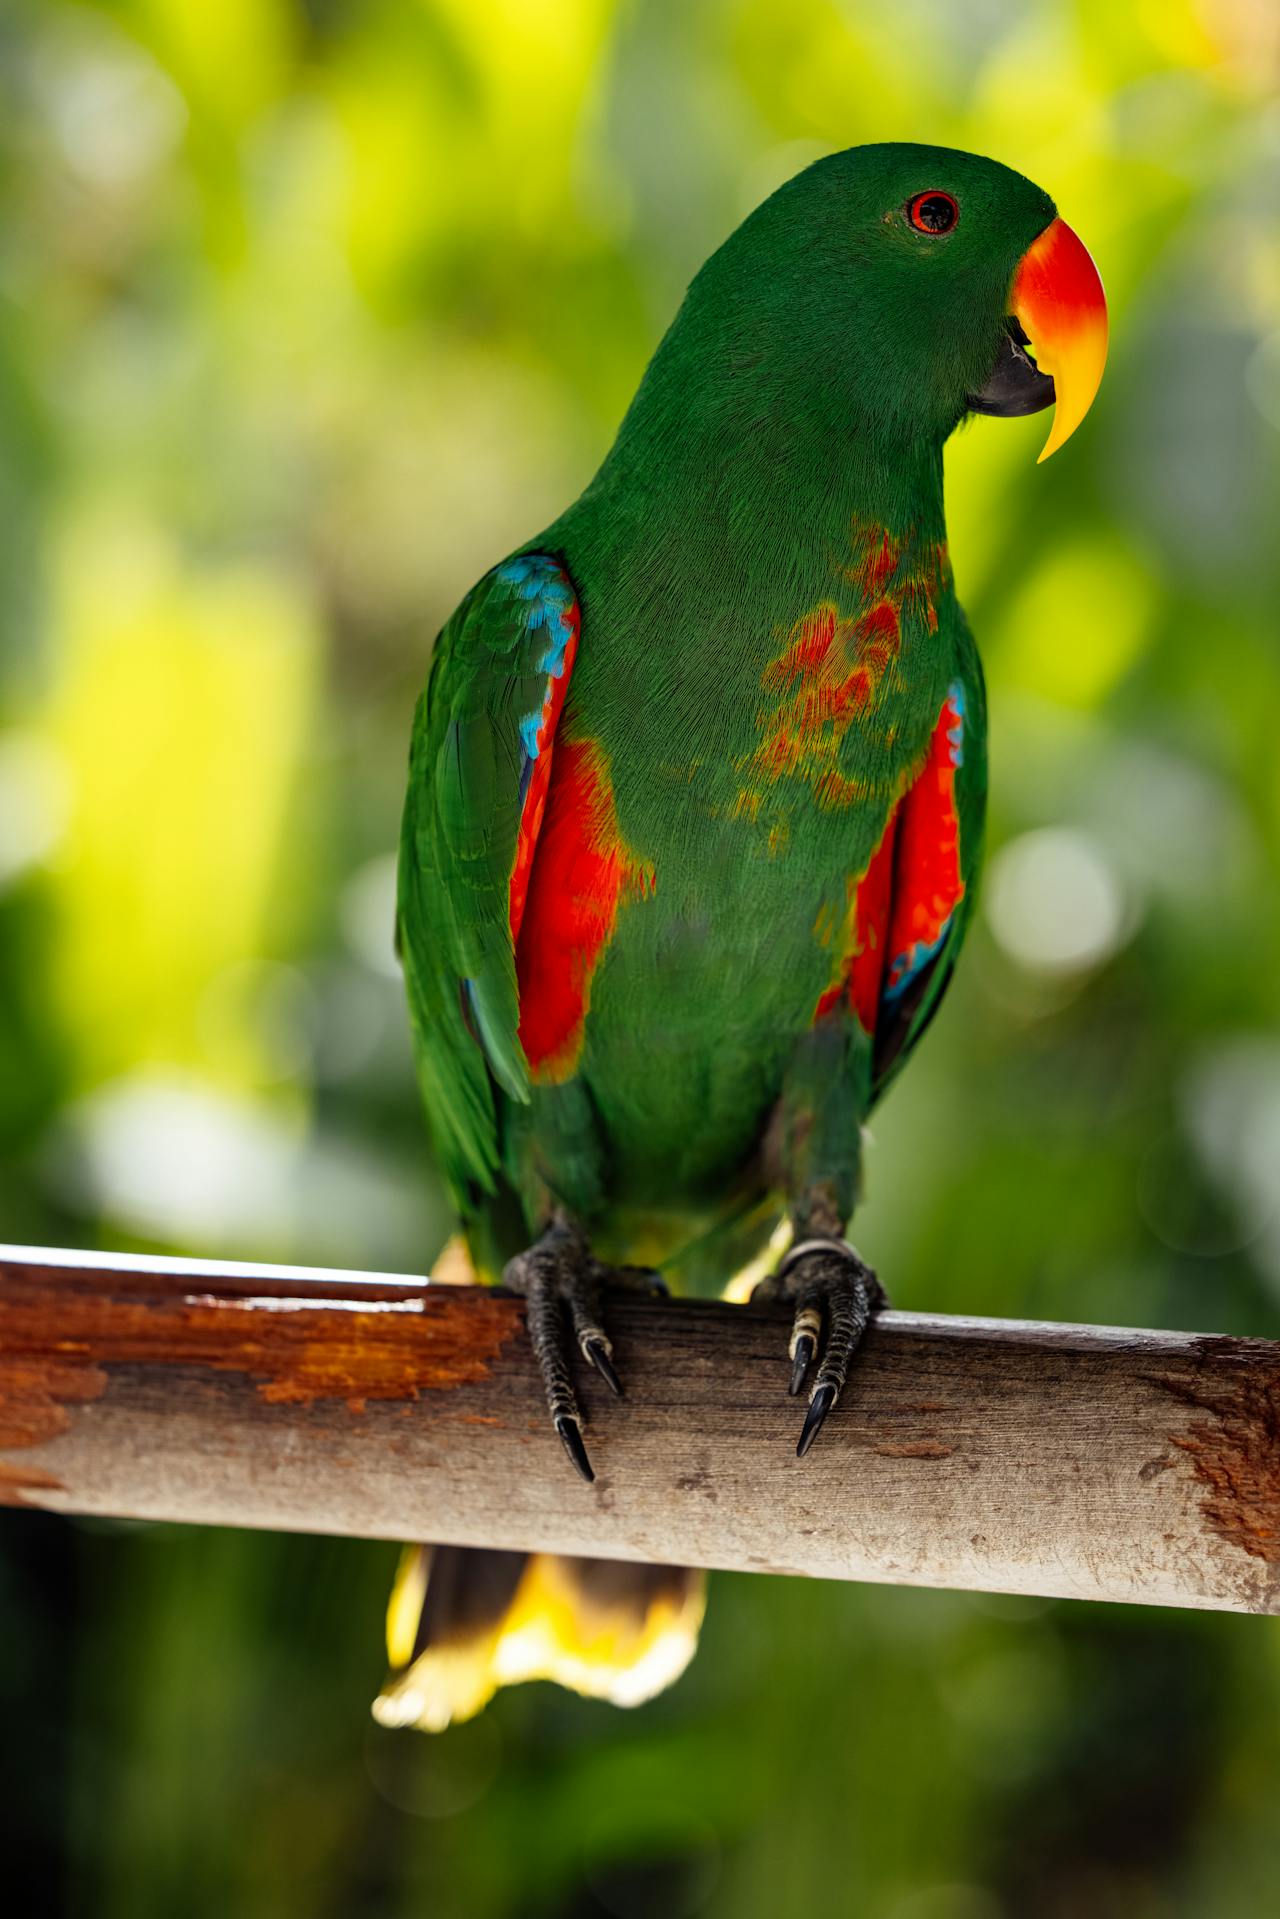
[871,654,986,1100]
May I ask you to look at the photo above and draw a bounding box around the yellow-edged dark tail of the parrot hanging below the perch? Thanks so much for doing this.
[374,1547,706,1733]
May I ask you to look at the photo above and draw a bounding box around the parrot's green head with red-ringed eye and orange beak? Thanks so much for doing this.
[695,144,1107,459]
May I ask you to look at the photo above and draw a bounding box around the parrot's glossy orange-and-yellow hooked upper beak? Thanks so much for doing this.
[1009,221,1107,461]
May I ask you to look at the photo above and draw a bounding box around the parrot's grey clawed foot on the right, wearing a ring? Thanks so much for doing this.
[752,1238,885,1458]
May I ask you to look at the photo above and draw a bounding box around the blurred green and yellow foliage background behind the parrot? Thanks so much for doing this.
[0,0,1280,1919]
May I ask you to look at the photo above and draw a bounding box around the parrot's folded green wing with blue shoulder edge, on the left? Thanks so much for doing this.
[397,553,578,1199]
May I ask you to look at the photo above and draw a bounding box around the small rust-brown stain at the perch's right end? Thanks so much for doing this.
[1159,1338,1280,1572]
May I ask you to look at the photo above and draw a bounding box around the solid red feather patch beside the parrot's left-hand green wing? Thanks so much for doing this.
[516,739,654,1084]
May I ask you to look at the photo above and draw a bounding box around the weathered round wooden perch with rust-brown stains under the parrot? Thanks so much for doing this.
[0,1247,1280,1612]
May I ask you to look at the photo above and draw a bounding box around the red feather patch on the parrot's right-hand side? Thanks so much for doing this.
[814,681,965,1034]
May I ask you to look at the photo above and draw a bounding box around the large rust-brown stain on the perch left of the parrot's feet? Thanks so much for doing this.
[0,1267,520,1449]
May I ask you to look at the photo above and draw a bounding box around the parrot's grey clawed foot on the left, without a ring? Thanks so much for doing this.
[503,1219,666,1481]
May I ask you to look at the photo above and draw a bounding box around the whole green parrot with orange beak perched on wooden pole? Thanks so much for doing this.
[374,144,1107,1727]
